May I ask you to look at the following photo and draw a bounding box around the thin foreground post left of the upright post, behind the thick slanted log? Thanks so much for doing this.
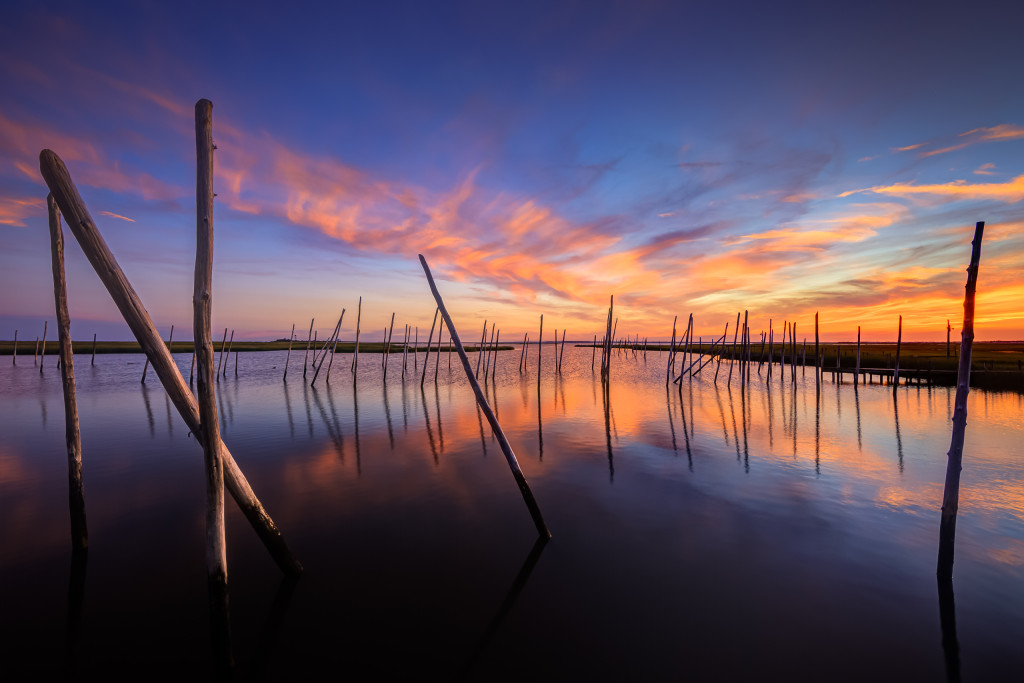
[46,195,89,551]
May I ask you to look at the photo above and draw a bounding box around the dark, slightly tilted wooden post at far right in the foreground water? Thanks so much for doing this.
[937,222,985,579]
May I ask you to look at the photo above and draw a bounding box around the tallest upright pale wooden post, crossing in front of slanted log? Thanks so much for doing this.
[193,99,230,655]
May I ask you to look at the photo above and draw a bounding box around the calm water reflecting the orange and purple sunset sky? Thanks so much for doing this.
[0,347,1024,681]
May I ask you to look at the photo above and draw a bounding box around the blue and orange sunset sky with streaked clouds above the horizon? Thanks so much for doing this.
[0,0,1024,341]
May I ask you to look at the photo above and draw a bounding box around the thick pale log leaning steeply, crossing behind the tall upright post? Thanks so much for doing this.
[39,150,302,575]
